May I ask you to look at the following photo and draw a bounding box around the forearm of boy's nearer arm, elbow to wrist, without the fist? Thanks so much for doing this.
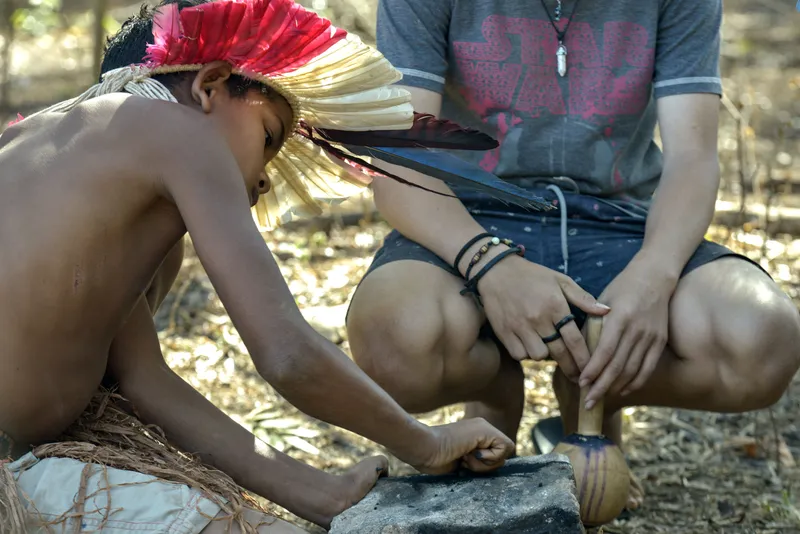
[253,323,435,465]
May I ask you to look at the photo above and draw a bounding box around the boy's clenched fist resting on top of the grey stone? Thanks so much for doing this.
[410,418,515,475]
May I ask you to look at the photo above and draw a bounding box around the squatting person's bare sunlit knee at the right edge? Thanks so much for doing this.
[670,260,800,412]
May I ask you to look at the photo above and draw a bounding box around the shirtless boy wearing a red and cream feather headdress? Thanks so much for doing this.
[0,0,513,533]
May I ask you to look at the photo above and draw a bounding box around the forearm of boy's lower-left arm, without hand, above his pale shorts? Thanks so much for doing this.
[120,364,340,523]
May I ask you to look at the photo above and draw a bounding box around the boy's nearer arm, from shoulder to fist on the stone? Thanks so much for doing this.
[159,112,513,472]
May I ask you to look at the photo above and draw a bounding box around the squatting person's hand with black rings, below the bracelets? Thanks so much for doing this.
[470,253,609,381]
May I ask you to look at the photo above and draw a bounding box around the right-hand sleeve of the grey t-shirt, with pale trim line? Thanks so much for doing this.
[653,0,722,98]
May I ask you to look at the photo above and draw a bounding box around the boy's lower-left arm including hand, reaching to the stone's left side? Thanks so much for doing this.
[108,297,386,528]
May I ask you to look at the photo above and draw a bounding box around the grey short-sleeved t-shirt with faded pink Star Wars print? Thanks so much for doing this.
[377,0,722,202]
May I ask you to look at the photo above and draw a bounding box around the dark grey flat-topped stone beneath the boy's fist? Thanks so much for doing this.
[330,454,585,534]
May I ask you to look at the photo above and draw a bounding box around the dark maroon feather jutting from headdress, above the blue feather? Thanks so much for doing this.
[314,112,499,150]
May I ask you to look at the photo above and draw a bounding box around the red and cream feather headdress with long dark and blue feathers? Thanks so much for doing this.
[4,0,548,230]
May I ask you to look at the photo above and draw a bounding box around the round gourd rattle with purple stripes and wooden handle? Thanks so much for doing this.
[553,317,630,526]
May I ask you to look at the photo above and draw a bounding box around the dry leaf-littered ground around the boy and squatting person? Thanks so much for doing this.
[158,216,800,534]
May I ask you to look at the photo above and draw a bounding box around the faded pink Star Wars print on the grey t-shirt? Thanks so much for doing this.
[453,15,655,176]
